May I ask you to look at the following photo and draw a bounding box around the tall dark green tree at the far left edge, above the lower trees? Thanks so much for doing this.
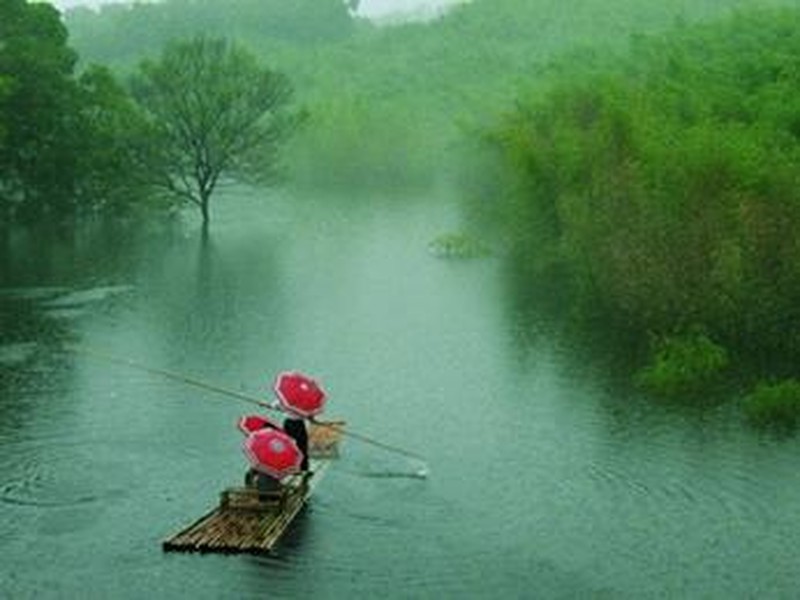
[0,0,77,218]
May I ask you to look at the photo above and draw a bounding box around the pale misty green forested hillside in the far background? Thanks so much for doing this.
[65,0,788,189]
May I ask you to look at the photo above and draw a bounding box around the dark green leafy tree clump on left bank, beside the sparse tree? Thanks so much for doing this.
[0,0,146,220]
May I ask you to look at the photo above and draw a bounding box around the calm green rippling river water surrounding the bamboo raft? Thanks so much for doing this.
[0,193,800,598]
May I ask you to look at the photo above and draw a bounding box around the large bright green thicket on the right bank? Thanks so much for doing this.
[484,9,800,418]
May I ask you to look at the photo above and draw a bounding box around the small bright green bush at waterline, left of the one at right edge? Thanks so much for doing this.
[635,333,729,397]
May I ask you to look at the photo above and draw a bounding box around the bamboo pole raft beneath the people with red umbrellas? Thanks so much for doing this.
[162,421,344,554]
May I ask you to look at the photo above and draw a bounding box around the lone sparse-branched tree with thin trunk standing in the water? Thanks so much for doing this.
[133,37,295,225]
